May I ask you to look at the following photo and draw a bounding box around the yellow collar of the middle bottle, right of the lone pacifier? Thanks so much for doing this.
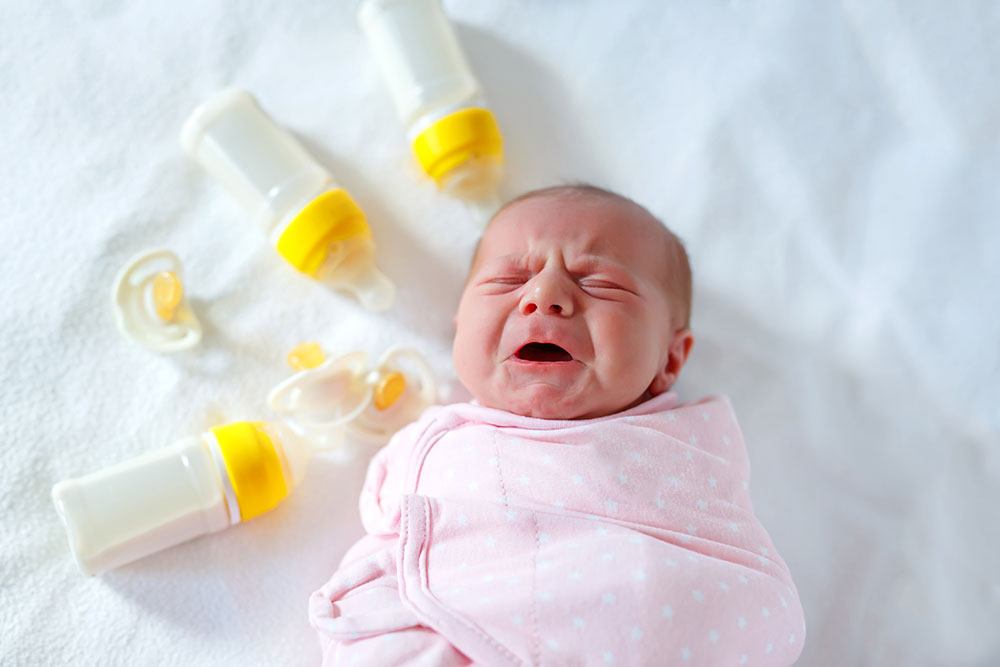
[277,189,372,277]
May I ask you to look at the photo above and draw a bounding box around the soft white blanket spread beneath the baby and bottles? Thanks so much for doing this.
[0,0,1000,666]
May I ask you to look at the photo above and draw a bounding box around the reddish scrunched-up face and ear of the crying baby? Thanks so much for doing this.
[454,196,691,419]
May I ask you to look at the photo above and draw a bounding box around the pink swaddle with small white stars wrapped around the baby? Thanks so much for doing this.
[310,393,805,665]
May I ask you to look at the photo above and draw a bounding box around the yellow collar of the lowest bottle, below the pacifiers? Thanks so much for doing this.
[212,422,288,521]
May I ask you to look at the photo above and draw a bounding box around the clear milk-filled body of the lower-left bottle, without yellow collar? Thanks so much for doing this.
[52,436,231,574]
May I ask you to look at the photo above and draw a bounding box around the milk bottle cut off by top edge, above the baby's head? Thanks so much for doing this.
[358,0,503,199]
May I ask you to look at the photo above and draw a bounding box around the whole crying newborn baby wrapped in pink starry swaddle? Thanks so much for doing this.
[310,186,805,666]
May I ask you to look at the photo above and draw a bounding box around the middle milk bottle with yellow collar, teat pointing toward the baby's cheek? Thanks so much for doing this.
[181,89,395,310]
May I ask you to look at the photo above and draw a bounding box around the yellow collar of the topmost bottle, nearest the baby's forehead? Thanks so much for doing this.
[413,107,503,185]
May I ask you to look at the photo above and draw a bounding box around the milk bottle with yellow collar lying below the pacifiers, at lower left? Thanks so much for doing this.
[52,422,312,574]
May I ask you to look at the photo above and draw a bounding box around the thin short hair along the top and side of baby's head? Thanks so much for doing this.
[472,183,692,327]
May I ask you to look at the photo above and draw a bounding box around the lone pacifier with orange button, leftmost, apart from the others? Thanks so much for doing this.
[111,250,201,352]
